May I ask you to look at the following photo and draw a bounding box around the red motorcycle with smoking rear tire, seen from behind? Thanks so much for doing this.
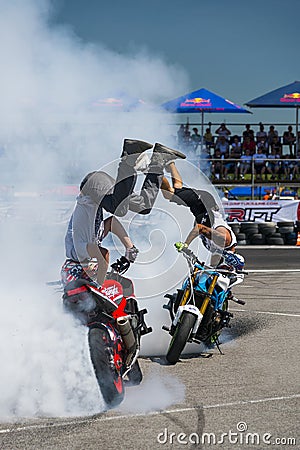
[63,257,152,407]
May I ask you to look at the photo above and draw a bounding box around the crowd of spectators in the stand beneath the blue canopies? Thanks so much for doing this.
[176,123,300,182]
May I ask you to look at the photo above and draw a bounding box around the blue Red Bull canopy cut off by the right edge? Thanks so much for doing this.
[246,81,300,151]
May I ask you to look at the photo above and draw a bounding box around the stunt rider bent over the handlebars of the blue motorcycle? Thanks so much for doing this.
[161,161,244,270]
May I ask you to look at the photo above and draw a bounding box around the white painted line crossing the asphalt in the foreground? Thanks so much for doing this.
[0,394,300,434]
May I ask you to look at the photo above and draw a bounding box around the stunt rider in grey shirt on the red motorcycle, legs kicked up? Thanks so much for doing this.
[61,139,185,286]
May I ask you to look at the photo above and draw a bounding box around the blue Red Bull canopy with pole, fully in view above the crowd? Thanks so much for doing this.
[161,89,252,147]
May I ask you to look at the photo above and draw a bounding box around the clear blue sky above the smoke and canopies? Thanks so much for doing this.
[52,0,300,127]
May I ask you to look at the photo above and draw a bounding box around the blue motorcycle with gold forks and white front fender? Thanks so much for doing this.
[162,244,247,364]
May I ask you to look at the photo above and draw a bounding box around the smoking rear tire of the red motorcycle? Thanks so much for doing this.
[88,328,124,408]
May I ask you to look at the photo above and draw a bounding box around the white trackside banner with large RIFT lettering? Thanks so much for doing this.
[223,200,300,223]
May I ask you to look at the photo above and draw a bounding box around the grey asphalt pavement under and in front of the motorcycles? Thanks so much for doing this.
[0,247,300,450]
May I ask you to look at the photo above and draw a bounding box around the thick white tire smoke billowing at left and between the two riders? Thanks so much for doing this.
[0,0,220,420]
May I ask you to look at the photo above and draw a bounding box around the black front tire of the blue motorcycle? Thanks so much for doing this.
[166,312,196,364]
